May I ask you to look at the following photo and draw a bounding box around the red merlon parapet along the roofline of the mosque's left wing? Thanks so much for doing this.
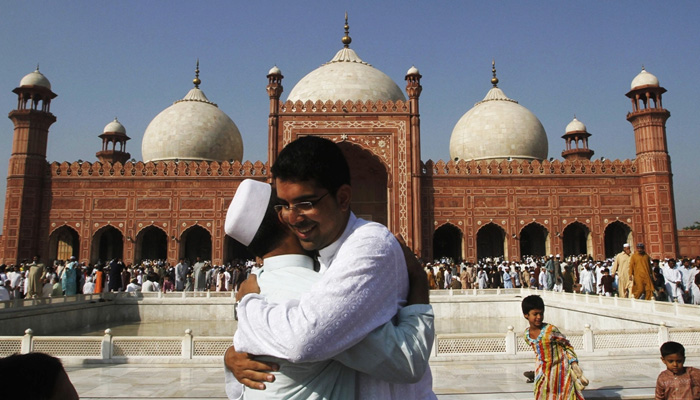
[49,160,268,178]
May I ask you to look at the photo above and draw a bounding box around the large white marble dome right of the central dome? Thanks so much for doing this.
[450,86,549,160]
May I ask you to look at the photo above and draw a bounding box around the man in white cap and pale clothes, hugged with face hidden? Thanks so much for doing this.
[225,179,433,400]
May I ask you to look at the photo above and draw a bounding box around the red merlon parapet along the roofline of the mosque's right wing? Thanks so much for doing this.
[421,159,637,176]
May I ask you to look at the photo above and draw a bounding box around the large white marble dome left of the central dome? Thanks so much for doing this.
[141,87,243,161]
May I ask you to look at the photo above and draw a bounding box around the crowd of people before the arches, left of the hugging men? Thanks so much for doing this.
[0,257,259,301]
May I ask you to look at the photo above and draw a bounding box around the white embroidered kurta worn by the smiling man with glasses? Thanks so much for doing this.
[234,214,436,400]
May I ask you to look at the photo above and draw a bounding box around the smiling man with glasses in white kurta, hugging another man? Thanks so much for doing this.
[225,136,436,400]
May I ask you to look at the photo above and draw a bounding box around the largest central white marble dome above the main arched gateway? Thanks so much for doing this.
[287,47,406,102]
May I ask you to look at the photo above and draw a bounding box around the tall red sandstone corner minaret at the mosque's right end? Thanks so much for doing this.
[627,67,678,258]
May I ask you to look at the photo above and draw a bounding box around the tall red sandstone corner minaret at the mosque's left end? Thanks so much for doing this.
[2,66,56,264]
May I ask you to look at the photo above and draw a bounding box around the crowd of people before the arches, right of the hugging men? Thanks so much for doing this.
[425,243,700,304]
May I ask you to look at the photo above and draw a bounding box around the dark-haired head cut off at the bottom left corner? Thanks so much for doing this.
[0,353,63,400]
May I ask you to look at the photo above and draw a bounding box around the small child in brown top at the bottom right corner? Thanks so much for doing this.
[655,342,700,400]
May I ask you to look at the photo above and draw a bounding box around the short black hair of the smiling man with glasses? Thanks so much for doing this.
[271,136,350,196]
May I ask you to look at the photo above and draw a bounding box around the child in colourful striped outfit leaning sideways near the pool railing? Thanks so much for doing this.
[522,295,588,400]
